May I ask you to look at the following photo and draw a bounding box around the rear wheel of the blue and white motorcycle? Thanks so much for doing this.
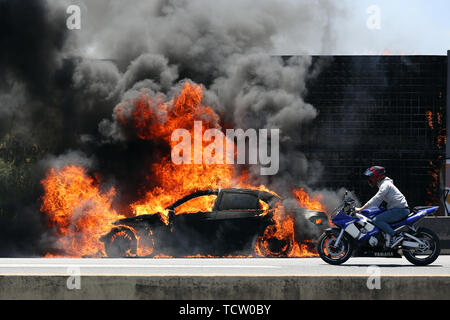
[402,228,441,266]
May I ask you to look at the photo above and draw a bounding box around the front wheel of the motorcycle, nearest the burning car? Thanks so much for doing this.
[317,232,353,265]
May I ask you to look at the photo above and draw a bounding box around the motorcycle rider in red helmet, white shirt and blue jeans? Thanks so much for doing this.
[356,166,410,248]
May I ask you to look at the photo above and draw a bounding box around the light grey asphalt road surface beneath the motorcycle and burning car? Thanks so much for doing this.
[0,256,450,276]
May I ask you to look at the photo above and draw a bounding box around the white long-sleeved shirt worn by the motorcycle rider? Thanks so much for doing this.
[364,177,408,210]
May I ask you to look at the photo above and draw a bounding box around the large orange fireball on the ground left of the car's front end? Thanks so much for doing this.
[41,165,124,257]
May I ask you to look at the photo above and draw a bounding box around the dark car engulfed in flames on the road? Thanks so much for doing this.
[101,188,329,257]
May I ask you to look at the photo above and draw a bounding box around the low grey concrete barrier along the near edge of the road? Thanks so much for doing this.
[0,275,450,300]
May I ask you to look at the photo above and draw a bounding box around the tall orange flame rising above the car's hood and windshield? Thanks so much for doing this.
[122,82,233,224]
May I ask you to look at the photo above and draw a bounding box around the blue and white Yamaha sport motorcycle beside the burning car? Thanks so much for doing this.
[317,192,441,266]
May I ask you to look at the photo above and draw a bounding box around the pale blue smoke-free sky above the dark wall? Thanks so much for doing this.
[336,0,450,55]
